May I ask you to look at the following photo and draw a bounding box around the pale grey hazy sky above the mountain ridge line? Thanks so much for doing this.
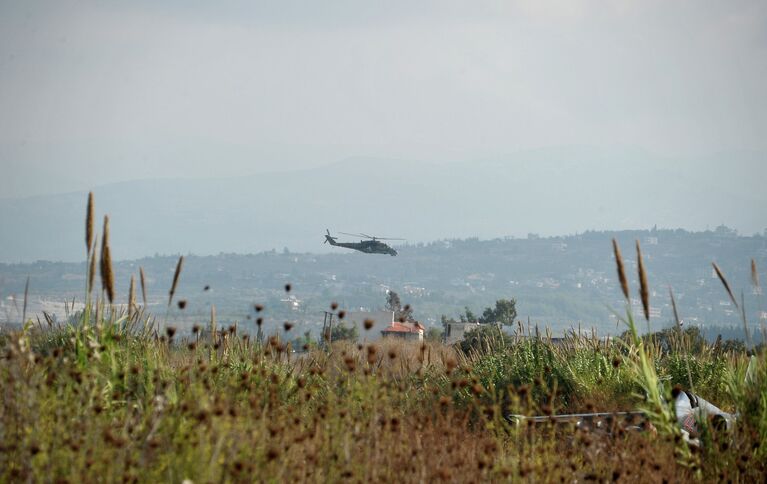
[0,0,767,197]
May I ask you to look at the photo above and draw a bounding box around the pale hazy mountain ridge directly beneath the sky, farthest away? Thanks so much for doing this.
[0,148,767,262]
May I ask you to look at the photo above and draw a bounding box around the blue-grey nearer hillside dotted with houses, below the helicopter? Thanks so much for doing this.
[0,226,767,338]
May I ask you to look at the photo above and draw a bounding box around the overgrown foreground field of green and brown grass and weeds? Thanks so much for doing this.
[0,195,767,482]
